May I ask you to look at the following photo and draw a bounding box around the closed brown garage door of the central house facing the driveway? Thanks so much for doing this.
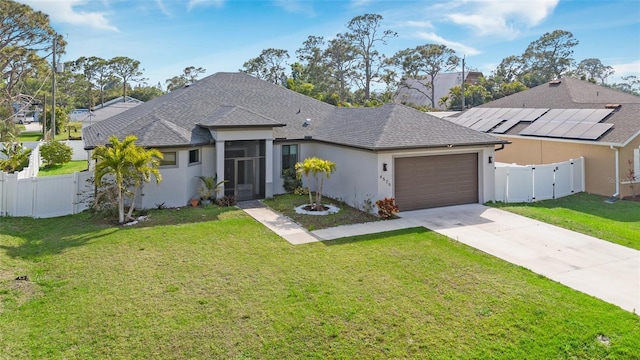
[394,153,478,211]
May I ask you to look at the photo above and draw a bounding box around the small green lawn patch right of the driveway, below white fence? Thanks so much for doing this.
[488,193,640,250]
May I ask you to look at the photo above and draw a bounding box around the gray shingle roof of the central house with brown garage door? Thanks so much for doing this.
[84,73,504,150]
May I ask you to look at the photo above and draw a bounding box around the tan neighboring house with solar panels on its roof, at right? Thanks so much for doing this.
[448,78,640,197]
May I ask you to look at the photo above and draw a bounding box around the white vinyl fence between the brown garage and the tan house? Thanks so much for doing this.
[495,157,584,203]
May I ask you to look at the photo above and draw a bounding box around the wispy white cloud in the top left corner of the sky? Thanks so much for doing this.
[20,0,118,31]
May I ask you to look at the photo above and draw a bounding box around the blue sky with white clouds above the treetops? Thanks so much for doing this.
[19,0,640,87]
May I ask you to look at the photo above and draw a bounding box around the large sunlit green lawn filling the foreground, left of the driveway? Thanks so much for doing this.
[0,206,640,359]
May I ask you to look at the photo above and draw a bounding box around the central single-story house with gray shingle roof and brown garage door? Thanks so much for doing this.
[84,73,505,210]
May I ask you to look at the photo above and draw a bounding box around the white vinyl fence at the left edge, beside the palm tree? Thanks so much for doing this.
[0,171,93,218]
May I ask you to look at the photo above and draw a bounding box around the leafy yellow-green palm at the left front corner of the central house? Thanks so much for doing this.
[92,135,162,223]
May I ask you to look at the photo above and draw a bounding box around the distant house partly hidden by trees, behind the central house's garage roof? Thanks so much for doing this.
[395,71,482,110]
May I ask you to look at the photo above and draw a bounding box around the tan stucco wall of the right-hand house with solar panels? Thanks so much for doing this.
[496,137,620,196]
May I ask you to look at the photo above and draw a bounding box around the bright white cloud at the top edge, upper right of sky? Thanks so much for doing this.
[446,0,559,39]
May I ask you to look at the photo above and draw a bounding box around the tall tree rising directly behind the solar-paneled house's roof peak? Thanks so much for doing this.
[521,30,579,83]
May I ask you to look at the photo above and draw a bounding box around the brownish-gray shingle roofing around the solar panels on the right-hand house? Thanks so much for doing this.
[480,78,640,144]
